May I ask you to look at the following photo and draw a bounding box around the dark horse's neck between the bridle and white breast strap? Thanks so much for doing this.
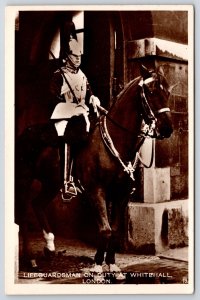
[107,80,142,160]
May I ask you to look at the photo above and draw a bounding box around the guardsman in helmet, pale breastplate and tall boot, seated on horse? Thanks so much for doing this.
[50,38,100,199]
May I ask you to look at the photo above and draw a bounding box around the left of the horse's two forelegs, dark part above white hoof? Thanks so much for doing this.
[91,188,112,265]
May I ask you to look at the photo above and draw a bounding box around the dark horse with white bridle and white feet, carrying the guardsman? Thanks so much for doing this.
[15,68,173,272]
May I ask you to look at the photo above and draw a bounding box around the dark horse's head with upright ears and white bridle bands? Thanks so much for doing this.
[139,66,173,139]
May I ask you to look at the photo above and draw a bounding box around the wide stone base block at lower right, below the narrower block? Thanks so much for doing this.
[125,200,188,254]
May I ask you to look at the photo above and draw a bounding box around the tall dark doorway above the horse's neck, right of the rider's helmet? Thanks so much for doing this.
[82,11,123,108]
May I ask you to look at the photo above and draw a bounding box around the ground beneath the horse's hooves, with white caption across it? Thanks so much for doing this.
[16,237,188,284]
